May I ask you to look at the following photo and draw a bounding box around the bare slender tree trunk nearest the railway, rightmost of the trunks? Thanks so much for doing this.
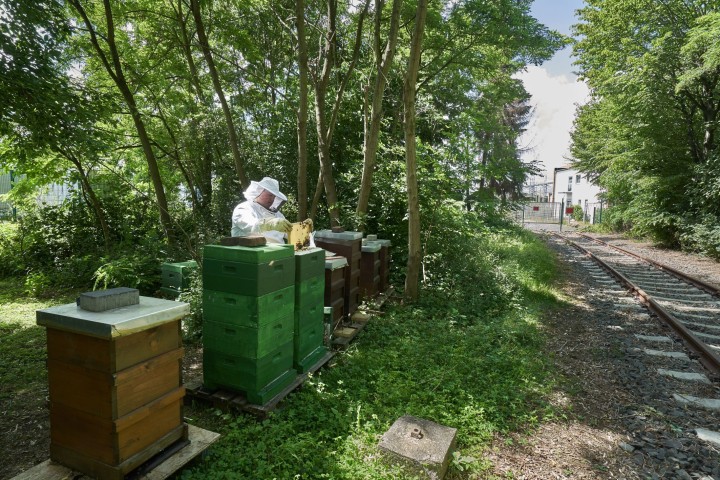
[403,0,428,301]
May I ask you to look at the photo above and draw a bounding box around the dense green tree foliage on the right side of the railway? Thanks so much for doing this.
[572,0,720,251]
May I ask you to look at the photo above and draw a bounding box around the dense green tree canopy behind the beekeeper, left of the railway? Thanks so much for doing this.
[0,0,564,296]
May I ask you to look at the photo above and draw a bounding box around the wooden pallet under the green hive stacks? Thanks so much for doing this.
[185,350,335,419]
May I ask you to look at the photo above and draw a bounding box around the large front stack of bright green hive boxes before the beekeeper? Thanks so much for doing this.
[203,245,297,405]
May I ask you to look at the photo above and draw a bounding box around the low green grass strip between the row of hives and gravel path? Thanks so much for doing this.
[181,230,562,480]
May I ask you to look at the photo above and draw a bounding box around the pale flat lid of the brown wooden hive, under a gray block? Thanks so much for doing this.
[35,296,190,339]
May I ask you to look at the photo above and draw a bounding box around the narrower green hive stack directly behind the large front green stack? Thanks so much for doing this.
[293,248,327,373]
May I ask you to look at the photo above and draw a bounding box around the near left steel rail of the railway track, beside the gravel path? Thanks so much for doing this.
[552,232,720,375]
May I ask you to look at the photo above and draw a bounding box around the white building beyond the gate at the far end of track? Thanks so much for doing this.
[551,166,603,223]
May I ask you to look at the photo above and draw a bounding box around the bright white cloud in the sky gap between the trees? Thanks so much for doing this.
[517,66,589,179]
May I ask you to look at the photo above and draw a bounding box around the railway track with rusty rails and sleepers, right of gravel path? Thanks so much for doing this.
[558,233,720,378]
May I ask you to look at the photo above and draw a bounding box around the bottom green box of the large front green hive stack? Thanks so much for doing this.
[203,341,295,394]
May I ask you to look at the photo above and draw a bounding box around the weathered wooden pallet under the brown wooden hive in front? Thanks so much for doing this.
[12,425,220,480]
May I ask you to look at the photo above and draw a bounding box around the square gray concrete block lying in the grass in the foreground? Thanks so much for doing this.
[379,415,457,480]
